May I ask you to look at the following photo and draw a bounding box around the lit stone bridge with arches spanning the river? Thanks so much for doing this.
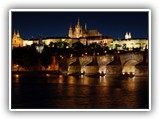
[69,52,148,75]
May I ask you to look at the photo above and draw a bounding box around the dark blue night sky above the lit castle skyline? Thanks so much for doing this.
[12,11,149,39]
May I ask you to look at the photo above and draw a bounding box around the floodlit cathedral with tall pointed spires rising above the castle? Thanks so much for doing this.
[68,18,102,38]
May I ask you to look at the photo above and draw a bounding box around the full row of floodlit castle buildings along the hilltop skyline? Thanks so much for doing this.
[12,19,148,50]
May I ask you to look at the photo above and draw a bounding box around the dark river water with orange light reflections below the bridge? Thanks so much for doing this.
[11,74,149,109]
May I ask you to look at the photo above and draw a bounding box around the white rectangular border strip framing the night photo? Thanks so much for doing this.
[9,9,151,111]
